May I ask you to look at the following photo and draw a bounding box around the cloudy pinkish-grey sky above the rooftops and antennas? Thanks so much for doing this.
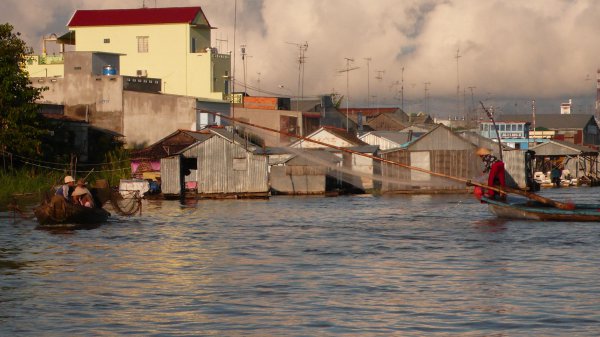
[0,0,600,118]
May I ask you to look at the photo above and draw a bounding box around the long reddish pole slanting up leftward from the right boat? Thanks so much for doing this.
[196,109,574,209]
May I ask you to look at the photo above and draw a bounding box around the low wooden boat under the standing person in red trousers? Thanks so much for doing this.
[481,197,600,222]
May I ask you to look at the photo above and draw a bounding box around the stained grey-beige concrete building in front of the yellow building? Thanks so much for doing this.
[31,52,206,148]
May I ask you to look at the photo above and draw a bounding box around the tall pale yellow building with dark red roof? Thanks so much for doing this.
[26,7,231,100]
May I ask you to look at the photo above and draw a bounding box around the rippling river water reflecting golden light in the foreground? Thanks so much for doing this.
[0,188,600,336]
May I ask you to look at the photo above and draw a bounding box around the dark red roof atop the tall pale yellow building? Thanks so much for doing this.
[67,7,210,27]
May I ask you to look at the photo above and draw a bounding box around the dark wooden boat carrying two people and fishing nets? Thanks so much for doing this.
[33,196,110,229]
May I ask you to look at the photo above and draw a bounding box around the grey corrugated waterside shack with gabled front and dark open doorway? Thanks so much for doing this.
[161,129,269,198]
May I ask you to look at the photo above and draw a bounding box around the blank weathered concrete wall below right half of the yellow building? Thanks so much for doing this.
[123,91,196,148]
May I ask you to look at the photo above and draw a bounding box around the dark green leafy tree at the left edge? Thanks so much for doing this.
[0,23,46,156]
